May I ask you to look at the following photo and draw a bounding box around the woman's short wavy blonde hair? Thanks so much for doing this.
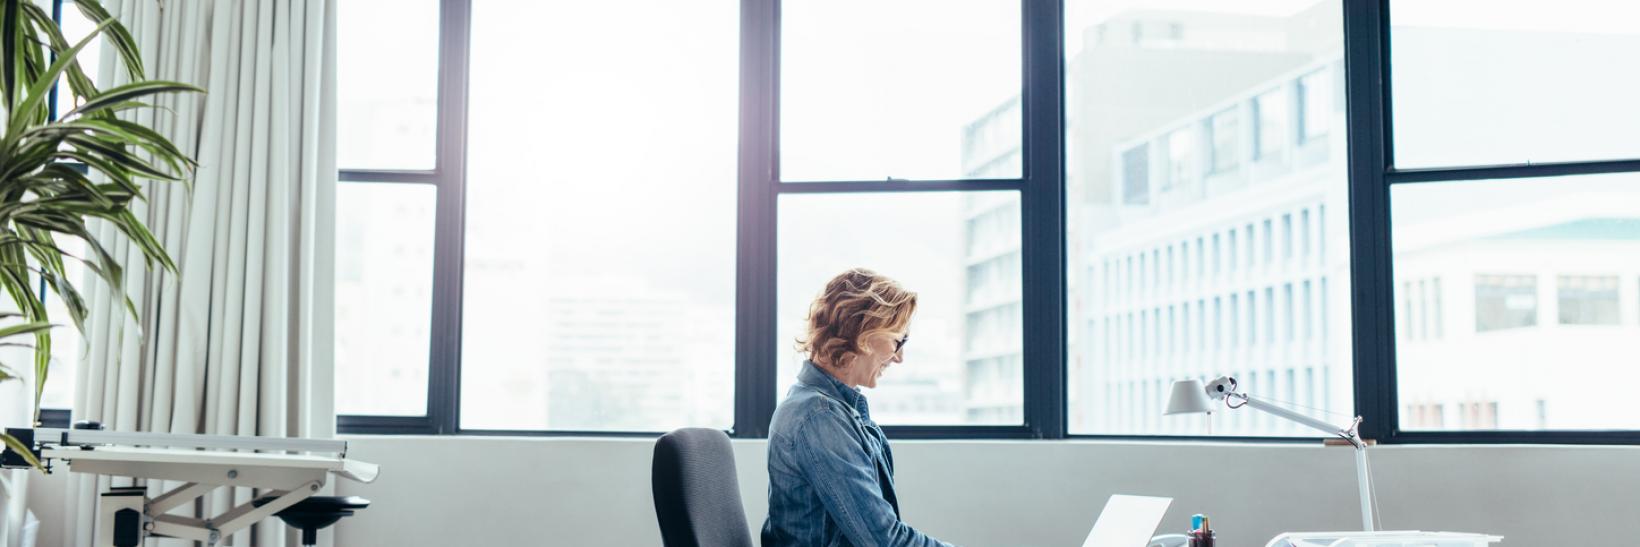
[797,269,917,368]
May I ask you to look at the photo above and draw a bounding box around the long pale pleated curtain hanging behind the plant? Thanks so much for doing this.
[66,0,336,545]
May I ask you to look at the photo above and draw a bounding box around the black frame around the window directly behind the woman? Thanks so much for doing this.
[733,0,1066,439]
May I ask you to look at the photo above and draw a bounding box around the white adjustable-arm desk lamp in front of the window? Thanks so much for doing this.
[1164,377,1373,532]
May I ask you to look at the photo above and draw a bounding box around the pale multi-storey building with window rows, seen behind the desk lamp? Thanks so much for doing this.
[1068,59,1350,434]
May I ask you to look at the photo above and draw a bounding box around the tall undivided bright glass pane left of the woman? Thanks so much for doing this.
[461,0,740,431]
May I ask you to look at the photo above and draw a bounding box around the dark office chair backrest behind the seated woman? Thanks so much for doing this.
[649,427,753,547]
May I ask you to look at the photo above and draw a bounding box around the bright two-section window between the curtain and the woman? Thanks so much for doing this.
[336,2,740,432]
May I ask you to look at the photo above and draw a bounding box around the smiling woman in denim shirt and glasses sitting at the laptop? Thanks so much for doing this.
[763,269,950,547]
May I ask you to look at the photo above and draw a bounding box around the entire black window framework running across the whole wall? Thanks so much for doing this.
[308,0,1640,444]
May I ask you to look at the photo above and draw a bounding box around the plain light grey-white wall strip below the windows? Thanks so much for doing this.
[326,437,1640,547]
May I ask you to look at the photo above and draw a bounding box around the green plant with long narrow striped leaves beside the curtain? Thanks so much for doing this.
[0,0,202,468]
